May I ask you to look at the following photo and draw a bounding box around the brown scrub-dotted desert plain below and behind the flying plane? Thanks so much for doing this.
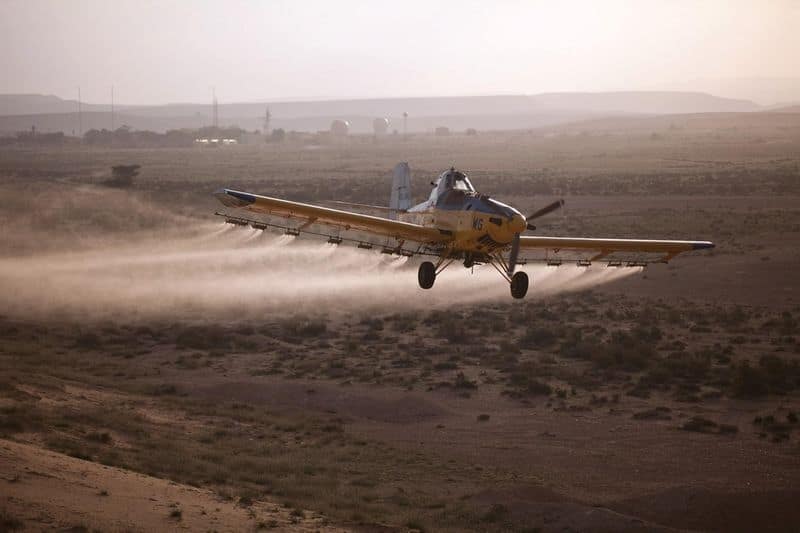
[0,113,800,532]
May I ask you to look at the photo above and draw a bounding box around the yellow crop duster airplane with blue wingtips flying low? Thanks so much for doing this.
[214,163,714,298]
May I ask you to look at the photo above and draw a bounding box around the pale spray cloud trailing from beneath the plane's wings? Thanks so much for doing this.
[0,223,638,321]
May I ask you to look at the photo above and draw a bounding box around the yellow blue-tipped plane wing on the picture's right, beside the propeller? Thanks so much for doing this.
[519,236,714,262]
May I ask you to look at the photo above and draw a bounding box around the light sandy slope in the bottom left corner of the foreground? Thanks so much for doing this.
[0,439,344,532]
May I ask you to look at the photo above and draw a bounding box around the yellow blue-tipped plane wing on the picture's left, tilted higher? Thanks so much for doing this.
[214,189,453,245]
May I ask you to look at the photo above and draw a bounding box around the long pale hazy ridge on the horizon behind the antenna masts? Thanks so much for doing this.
[0,91,760,134]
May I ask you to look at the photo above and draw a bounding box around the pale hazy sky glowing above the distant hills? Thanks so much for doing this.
[0,0,800,104]
